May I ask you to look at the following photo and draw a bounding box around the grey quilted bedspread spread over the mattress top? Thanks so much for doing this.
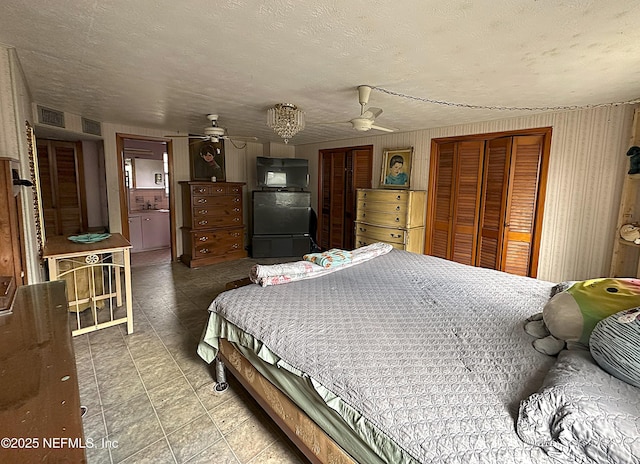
[205,250,573,464]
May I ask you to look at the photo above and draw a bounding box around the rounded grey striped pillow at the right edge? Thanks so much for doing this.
[589,308,640,393]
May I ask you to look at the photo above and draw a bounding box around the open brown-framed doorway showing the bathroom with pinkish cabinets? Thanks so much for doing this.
[116,134,177,266]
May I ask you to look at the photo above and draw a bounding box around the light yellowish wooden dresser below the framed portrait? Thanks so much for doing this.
[355,189,427,254]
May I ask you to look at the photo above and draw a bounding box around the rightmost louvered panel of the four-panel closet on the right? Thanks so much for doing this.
[500,136,544,275]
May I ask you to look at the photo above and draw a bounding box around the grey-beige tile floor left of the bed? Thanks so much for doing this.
[74,252,308,464]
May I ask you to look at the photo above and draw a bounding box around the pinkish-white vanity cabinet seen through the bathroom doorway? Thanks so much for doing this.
[129,211,171,253]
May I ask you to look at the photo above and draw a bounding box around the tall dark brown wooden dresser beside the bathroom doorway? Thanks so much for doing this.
[180,181,247,267]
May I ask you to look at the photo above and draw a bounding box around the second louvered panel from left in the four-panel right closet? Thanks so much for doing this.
[450,141,484,265]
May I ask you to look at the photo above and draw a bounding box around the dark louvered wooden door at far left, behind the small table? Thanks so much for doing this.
[37,139,87,236]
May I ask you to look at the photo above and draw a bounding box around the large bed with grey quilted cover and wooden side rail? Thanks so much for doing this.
[198,249,640,464]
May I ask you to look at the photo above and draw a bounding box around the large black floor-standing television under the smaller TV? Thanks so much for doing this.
[251,190,311,258]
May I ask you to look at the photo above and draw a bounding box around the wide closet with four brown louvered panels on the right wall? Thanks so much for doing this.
[425,128,551,277]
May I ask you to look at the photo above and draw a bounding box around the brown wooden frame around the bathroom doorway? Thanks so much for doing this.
[116,132,178,262]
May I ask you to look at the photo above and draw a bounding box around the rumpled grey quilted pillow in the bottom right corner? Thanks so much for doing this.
[517,350,640,464]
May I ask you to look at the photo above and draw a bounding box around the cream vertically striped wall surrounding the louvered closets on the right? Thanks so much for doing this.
[296,105,634,282]
